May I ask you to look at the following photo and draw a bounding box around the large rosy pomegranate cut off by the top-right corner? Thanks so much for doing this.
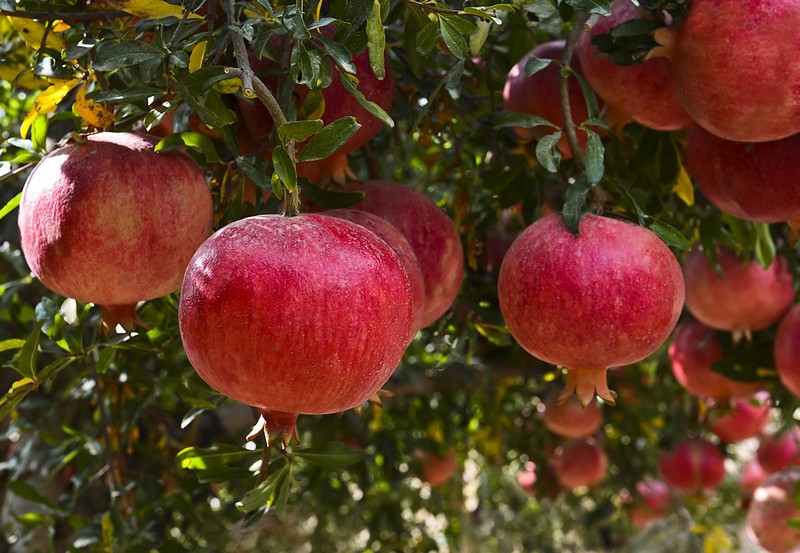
[672,0,800,142]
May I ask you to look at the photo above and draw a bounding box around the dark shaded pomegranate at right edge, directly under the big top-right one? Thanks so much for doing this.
[686,125,800,223]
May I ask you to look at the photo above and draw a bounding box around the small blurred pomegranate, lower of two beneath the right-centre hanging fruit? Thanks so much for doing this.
[552,438,608,490]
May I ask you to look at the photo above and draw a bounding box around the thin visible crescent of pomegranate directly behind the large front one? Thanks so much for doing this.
[325,209,425,339]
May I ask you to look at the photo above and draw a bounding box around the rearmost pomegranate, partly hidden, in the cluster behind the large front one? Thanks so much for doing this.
[348,180,464,327]
